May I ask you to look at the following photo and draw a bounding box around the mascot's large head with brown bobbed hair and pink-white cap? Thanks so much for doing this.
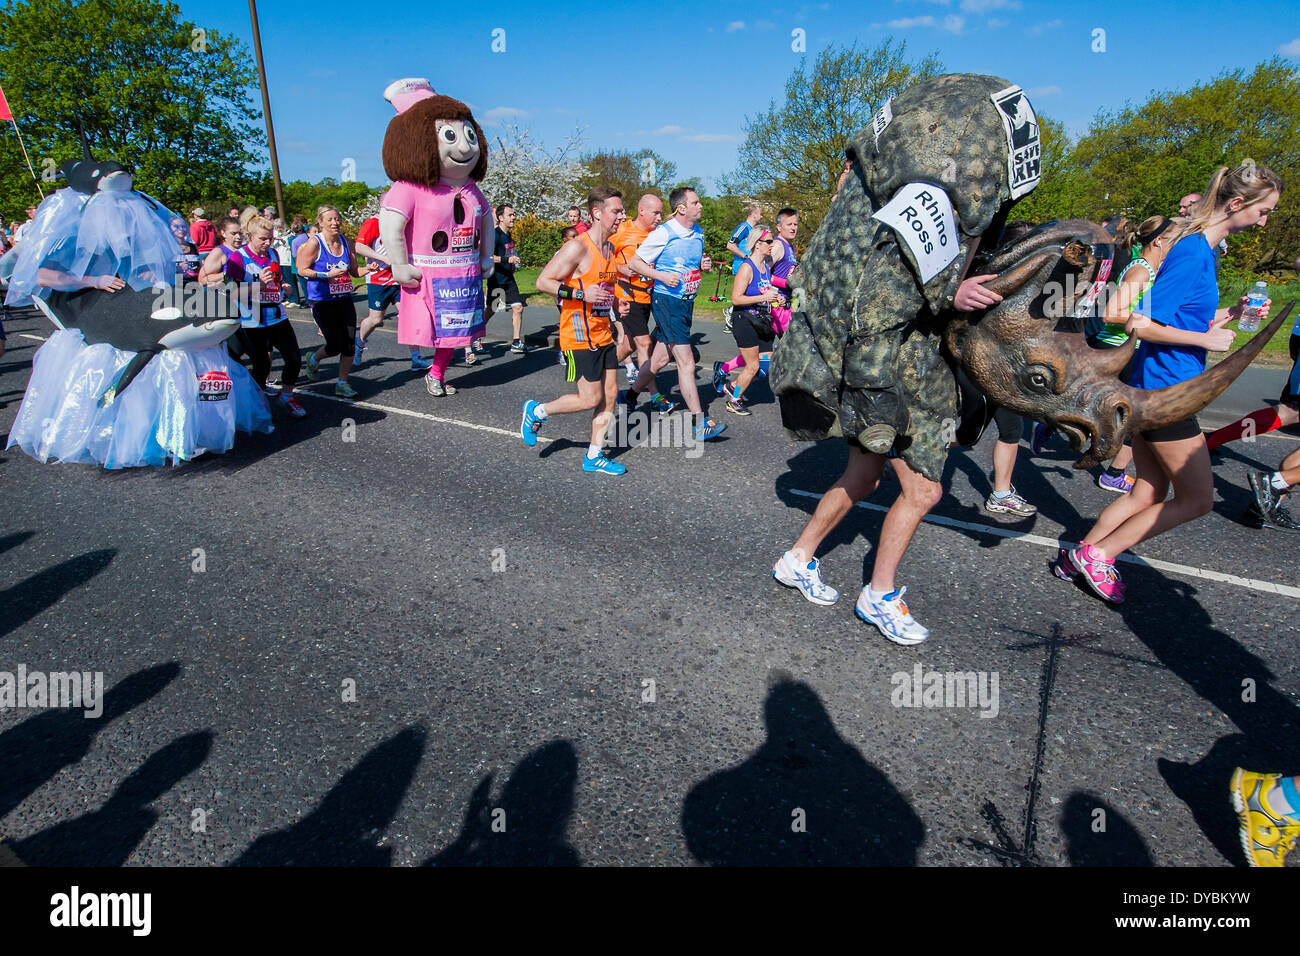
[384,79,488,189]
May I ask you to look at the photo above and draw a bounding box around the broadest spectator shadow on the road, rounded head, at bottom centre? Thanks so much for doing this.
[681,675,924,866]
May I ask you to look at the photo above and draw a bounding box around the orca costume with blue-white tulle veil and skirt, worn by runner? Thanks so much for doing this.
[5,144,272,468]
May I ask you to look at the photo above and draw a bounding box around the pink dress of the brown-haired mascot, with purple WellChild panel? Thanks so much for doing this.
[384,179,488,349]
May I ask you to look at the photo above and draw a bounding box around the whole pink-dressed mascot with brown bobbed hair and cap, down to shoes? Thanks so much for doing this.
[380,79,494,397]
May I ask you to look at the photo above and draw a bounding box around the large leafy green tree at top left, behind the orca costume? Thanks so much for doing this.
[0,0,264,208]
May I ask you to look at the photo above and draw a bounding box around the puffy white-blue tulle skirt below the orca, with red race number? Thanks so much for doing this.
[8,329,272,468]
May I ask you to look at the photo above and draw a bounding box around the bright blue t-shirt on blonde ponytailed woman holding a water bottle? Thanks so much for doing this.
[1128,233,1218,389]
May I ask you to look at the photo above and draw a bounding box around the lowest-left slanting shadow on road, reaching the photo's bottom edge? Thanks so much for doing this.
[12,731,213,866]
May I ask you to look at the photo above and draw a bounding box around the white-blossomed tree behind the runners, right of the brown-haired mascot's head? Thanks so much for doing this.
[478,122,586,220]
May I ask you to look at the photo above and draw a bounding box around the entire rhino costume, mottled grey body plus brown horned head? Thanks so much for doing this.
[772,74,1281,481]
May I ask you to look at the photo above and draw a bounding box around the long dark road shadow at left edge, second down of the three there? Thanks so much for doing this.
[0,661,181,819]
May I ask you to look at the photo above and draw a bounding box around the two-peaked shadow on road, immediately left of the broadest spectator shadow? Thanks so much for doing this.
[425,740,582,866]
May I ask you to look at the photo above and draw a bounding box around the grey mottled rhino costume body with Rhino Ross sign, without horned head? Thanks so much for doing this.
[771,74,1040,481]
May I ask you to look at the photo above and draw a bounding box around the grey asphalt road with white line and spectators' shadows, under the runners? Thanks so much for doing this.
[0,307,1300,866]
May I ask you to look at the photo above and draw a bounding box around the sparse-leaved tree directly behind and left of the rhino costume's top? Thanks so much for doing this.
[725,38,943,235]
